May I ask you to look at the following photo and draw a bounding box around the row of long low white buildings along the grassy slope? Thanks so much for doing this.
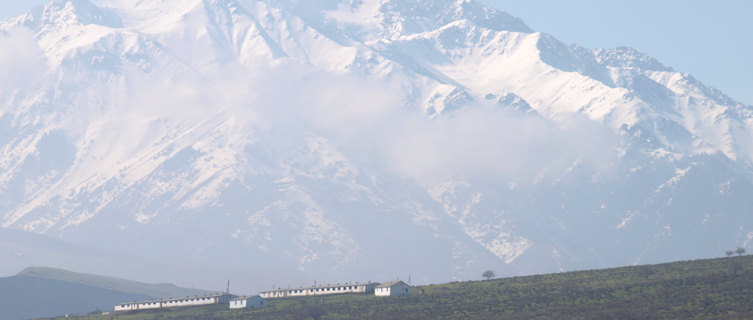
[114,281,413,312]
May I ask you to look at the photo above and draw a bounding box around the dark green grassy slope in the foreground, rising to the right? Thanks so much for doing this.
[48,256,753,320]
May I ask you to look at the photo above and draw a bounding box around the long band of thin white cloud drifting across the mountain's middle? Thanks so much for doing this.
[7,41,616,199]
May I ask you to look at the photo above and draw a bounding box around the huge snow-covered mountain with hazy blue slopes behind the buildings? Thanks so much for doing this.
[0,0,753,288]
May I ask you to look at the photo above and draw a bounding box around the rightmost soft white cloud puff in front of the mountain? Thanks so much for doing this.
[387,106,614,182]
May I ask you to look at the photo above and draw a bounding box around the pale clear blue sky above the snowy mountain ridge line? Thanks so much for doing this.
[0,0,753,105]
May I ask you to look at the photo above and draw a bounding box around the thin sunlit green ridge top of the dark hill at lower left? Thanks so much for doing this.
[18,267,208,298]
